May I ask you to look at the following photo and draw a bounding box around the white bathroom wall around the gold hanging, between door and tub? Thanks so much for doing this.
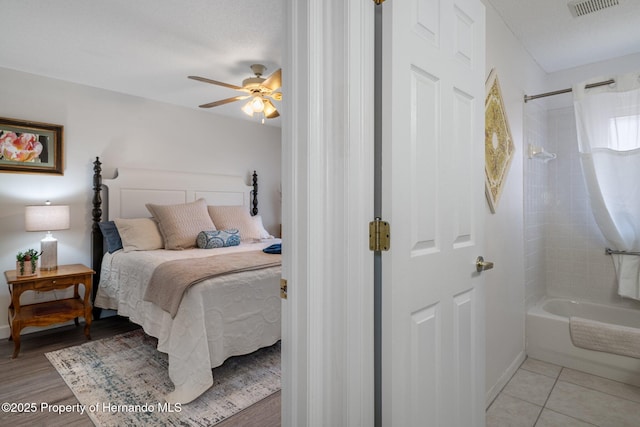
[478,0,545,403]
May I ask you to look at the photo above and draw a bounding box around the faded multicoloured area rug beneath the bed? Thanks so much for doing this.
[46,329,280,426]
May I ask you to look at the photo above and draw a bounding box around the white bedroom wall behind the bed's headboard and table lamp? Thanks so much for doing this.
[0,68,281,337]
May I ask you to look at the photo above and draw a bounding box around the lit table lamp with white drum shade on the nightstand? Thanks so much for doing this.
[24,200,69,270]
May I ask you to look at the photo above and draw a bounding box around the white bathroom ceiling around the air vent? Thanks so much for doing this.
[487,0,640,73]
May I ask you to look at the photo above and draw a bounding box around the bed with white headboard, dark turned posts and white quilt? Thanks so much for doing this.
[92,158,281,404]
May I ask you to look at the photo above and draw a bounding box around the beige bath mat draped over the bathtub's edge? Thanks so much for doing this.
[569,317,640,359]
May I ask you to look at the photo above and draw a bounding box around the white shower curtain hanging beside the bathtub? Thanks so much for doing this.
[573,73,640,299]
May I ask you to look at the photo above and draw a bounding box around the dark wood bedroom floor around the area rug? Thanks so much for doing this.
[0,316,280,427]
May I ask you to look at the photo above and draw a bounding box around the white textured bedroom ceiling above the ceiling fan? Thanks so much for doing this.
[0,0,283,125]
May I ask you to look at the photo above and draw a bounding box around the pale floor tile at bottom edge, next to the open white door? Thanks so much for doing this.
[486,393,542,427]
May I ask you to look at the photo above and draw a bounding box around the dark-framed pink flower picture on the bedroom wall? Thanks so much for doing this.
[0,118,64,175]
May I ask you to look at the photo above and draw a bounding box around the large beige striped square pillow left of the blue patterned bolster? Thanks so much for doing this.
[146,199,216,250]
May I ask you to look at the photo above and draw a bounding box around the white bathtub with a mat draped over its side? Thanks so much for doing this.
[525,298,640,386]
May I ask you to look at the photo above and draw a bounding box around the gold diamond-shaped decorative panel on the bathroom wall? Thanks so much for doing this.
[484,68,515,213]
